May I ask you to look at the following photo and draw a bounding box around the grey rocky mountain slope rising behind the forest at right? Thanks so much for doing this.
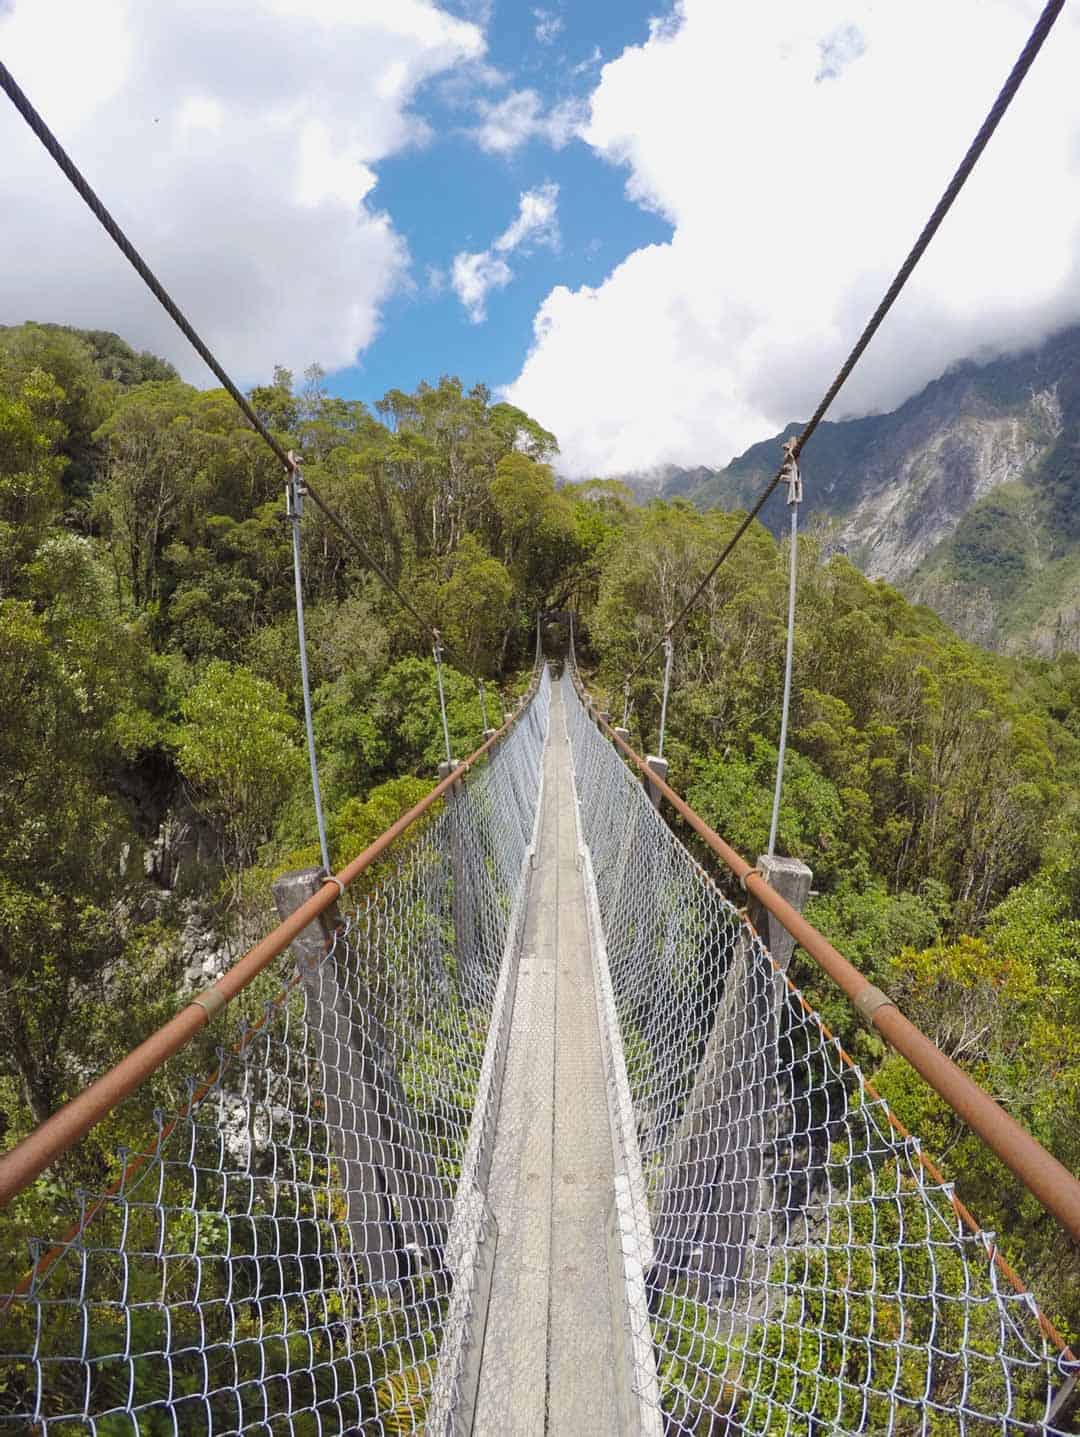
[623,326,1080,654]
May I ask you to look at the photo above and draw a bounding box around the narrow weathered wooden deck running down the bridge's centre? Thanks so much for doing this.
[474,685,620,1437]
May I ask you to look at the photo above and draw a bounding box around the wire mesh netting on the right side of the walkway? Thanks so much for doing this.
[563,675,1069,1437]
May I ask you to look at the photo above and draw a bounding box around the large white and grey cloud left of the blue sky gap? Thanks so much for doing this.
[0,0,484,382]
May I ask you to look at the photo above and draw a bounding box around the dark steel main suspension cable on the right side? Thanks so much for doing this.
[626,0,1066,683]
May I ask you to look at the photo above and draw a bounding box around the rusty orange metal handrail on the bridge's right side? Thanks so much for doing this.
[570,665,1080,1243]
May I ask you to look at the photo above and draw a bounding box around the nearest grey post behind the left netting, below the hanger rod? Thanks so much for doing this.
[273,868,445,1283]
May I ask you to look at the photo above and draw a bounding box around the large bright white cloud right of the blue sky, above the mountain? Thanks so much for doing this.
[508,0,1080,473]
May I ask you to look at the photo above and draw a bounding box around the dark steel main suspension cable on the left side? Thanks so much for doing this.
[0,60,485,692]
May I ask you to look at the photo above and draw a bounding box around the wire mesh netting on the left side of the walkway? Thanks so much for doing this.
[0,670,549,1437]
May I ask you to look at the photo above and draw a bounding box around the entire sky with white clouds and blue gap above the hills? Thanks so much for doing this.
[0,0,1080,474]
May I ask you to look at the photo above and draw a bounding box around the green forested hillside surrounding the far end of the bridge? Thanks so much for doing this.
[0,325,1080,1331]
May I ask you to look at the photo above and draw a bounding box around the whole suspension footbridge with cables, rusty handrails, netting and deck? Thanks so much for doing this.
[0,0,1080,1437]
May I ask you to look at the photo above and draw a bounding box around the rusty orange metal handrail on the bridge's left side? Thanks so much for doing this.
[0,670,540,1209]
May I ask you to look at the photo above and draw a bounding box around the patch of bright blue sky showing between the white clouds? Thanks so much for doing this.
[338,0,671,401]
